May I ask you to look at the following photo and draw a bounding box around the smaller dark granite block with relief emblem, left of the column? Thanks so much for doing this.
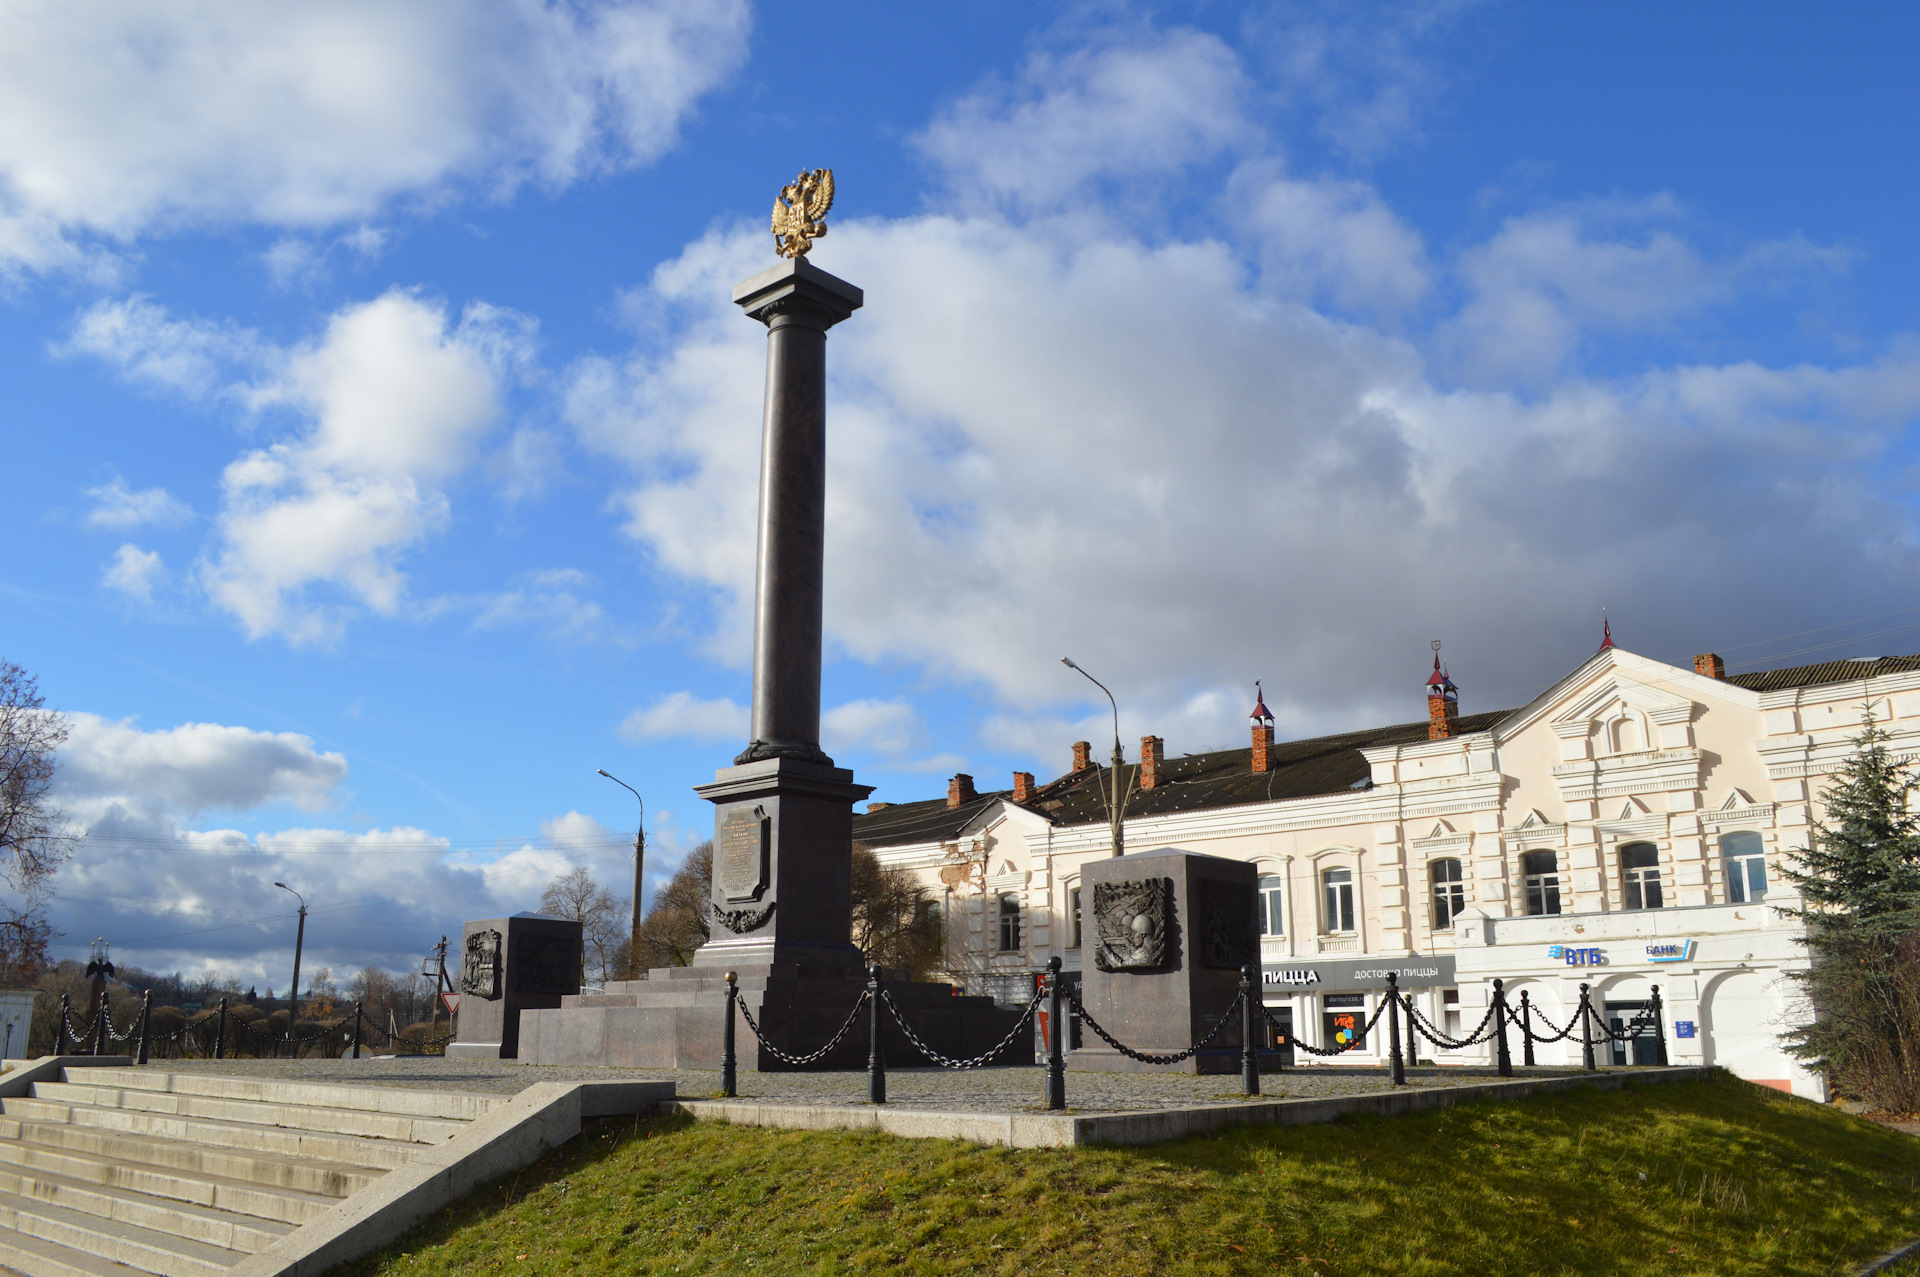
[447,914,582,1060]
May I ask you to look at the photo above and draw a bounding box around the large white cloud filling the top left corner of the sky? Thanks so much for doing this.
[0,0,749,269]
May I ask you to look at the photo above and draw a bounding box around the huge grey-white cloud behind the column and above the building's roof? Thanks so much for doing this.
[568,27,1920,757]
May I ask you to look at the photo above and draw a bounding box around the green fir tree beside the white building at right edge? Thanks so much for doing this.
[1780,711,1920,1112]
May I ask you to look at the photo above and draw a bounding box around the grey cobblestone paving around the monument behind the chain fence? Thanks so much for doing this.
[152,1056,1628,1114]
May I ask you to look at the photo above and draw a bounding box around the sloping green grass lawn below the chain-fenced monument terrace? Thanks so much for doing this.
[344,1075,1920,1277]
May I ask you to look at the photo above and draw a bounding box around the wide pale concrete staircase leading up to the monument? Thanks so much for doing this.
[0,1066,511,1277]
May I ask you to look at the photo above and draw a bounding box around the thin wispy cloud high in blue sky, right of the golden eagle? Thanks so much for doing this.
[918,31,1252,215]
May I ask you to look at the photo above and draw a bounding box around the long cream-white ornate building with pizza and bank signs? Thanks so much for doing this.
[854,639,1920,1098]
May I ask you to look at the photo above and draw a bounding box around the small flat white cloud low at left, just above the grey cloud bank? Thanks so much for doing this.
[56,712,348,822]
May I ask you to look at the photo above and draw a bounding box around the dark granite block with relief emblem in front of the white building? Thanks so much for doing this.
[1068,849,1281,1073]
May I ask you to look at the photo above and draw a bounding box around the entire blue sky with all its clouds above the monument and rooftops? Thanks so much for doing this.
[0,0,1920,987]
